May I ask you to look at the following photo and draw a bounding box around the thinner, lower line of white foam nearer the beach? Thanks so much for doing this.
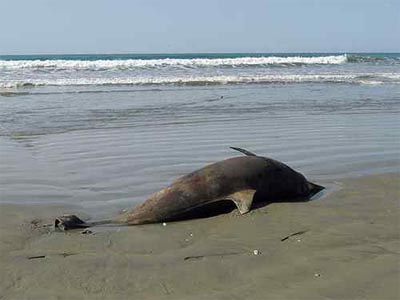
[0,73,400,88]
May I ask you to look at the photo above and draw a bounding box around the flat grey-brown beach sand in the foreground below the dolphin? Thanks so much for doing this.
[0,174,400,299]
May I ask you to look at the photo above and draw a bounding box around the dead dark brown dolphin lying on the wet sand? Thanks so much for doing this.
[55,147,324,230]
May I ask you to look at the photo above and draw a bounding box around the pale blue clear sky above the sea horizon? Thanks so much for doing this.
[0,0,400,54]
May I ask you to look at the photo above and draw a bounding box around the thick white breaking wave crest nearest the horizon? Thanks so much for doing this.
[0,55,347,70]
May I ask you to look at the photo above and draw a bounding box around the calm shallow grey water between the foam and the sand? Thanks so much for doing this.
[0,84,400,218]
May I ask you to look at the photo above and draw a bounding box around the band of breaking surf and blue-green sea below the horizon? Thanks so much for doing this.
[0,53,400,89]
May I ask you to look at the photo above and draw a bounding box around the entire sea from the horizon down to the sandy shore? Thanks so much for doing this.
[0,53,400,214]
